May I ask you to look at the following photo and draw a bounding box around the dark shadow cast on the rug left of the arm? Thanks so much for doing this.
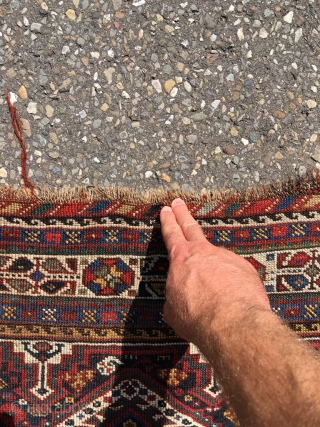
[101,224,188,427]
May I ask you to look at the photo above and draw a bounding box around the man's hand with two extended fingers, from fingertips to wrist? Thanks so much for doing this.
[160,199,270,345]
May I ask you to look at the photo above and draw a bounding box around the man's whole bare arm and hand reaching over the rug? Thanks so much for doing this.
[160,199,320,427]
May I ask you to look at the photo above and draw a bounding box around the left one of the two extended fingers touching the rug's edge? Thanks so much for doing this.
[160,206,187,252]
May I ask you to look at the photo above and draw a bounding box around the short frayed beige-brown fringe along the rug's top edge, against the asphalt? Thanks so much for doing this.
[0,169,320,205]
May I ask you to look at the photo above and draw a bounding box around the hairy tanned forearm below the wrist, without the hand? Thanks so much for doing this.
[200,310,320,427]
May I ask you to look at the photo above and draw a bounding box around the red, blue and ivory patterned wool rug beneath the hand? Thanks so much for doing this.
[0,177,320,427]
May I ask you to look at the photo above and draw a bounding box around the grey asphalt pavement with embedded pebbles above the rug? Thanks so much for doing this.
[0,0,320,191]
